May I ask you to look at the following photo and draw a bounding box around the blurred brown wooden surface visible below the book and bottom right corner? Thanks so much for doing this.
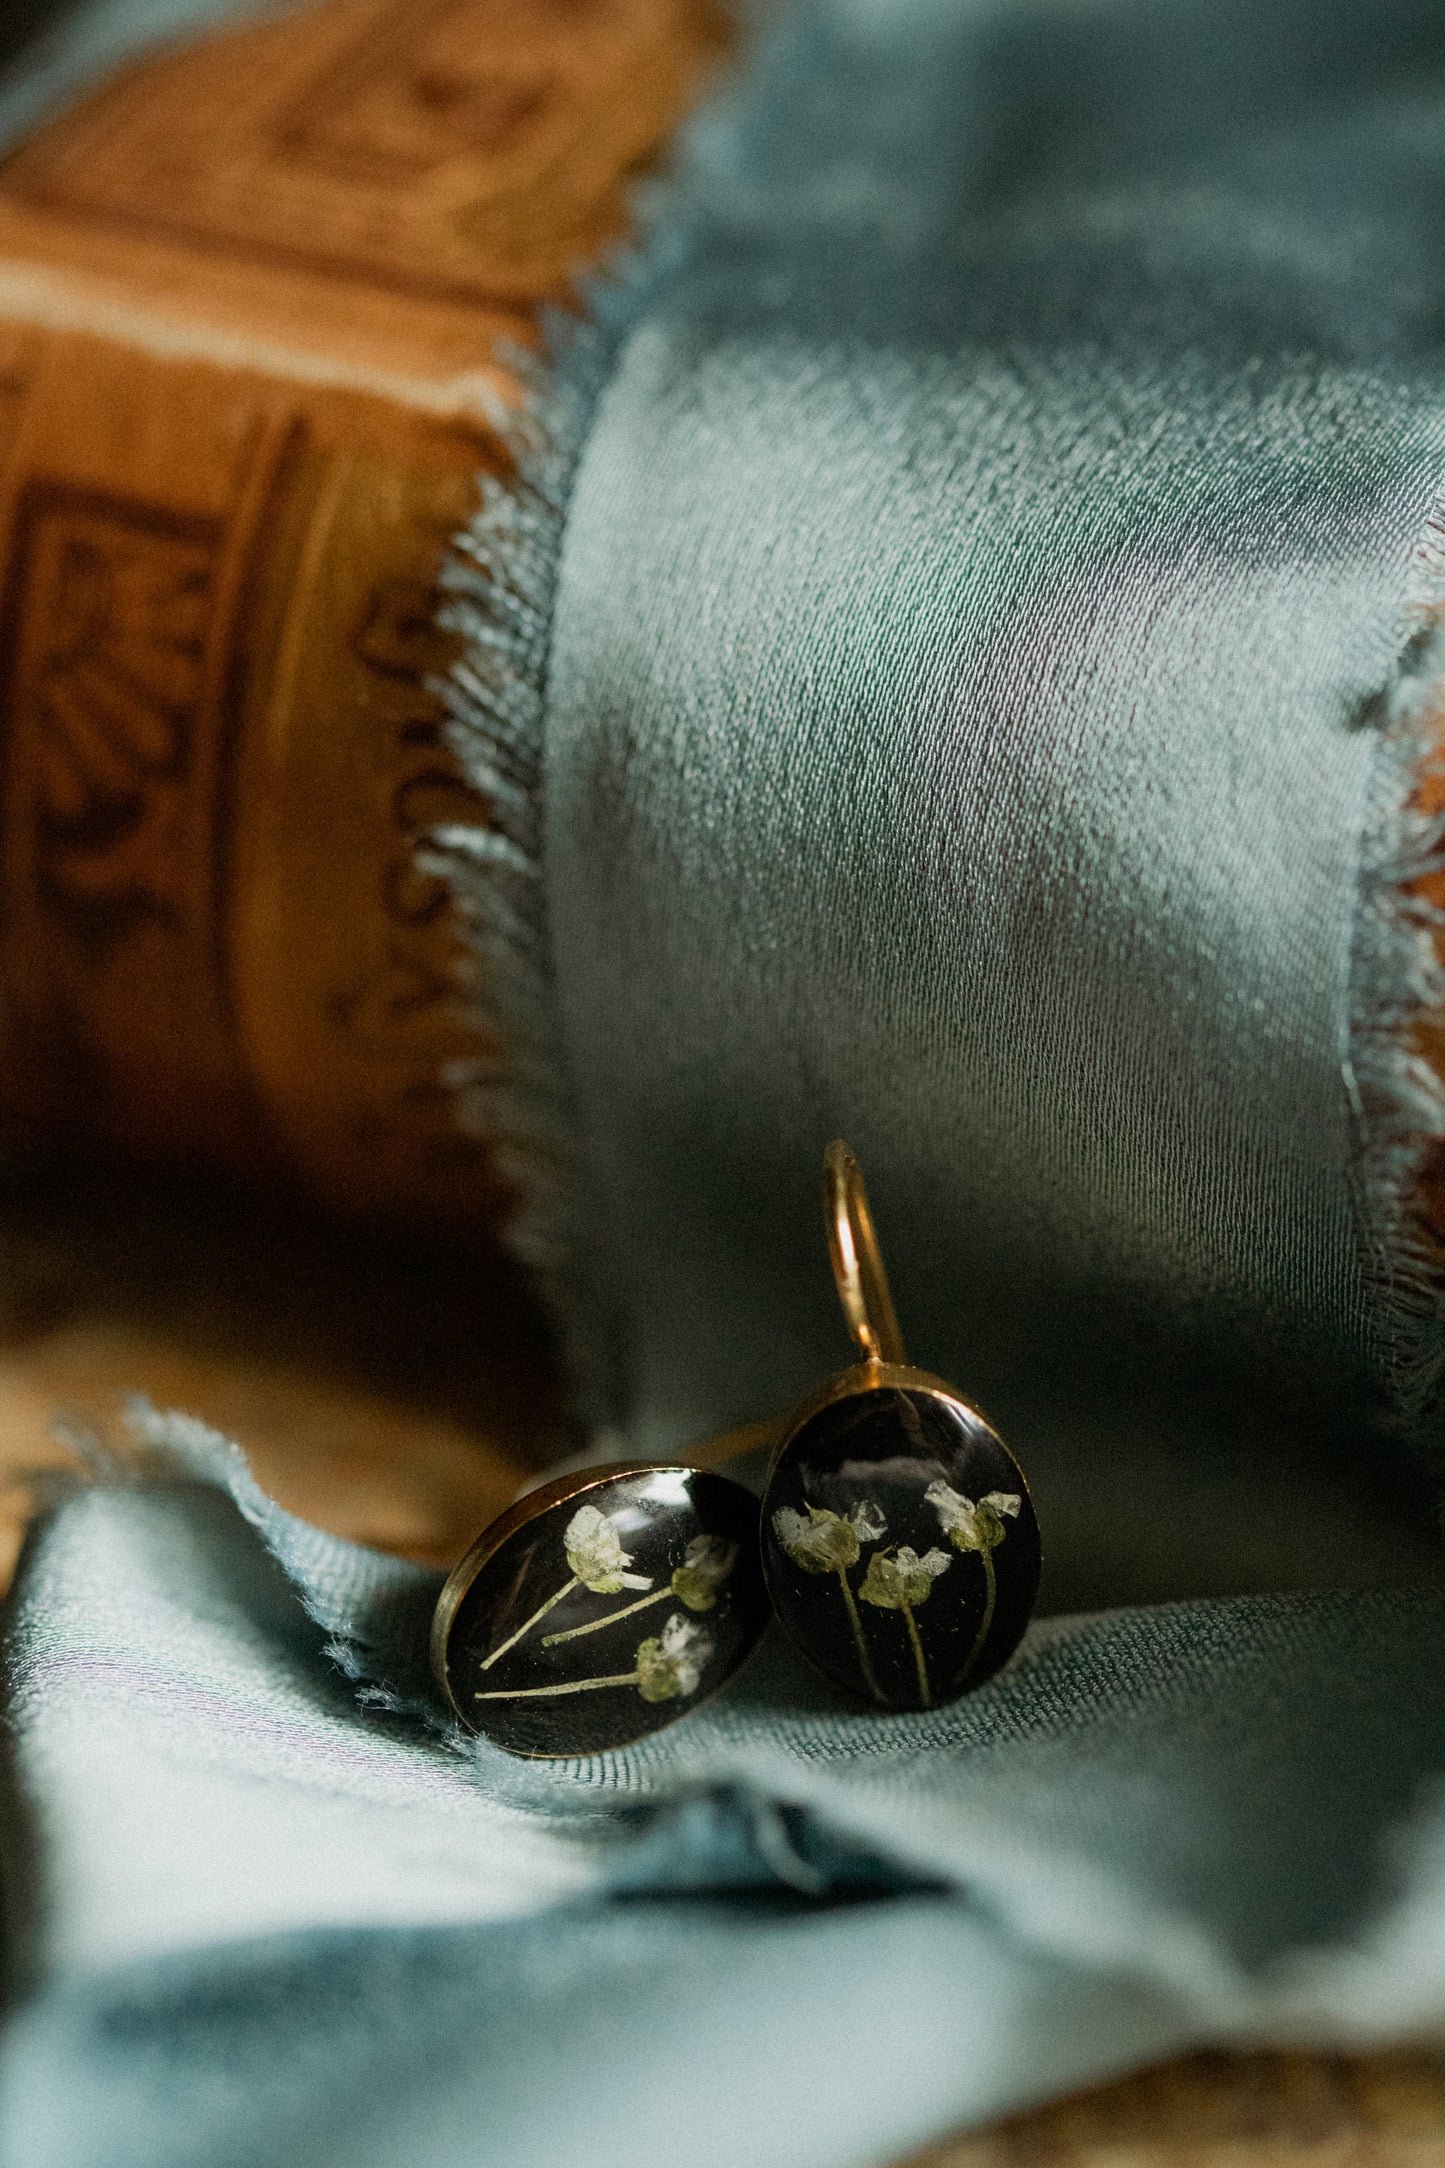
[0,1173,1445,2168]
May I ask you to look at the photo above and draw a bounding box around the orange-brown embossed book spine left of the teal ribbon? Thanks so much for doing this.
[0,327,513,1225]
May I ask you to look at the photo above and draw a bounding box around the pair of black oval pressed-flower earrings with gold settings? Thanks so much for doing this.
[431,1145,1040,1756]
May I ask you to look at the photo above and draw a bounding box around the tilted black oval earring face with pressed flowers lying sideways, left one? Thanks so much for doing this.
[446,1468,769,1754]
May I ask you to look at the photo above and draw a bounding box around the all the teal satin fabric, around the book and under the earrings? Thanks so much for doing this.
[0,0,1445,2168]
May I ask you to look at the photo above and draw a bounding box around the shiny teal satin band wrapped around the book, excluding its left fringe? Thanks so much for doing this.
[511,0,1445,1474]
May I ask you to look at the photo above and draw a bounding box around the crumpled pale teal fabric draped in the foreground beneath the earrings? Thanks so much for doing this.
[0,1416,1445,2168]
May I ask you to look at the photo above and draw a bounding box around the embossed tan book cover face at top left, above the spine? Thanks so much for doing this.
[4,0,717,301]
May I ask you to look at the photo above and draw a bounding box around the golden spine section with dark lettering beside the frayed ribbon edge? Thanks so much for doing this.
[230,436,519,1229]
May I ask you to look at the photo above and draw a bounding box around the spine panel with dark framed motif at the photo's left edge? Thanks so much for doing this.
[0,364,290,1153]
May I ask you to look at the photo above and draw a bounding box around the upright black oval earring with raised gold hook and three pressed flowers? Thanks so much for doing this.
[763,1143,1040,1708]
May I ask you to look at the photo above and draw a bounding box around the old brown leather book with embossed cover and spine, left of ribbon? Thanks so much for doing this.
[0,0,719,1229]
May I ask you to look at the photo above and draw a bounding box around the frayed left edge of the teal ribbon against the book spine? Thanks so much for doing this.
[420,245,672,1422]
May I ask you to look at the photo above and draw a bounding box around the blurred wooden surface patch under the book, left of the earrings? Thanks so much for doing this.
[0,1171,570,1578]
